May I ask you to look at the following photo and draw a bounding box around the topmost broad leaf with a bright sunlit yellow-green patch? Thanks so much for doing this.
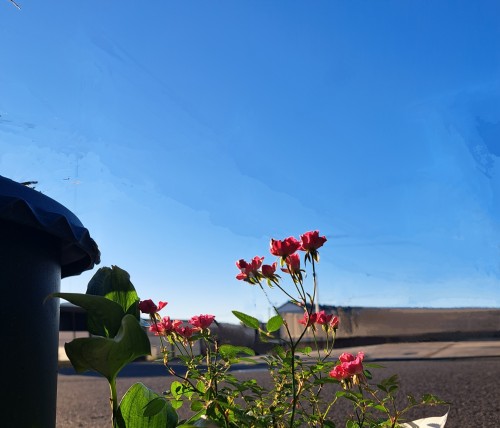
[87,266,139,319]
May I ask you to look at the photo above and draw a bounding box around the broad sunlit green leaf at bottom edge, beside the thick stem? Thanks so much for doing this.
[119,383,179,428]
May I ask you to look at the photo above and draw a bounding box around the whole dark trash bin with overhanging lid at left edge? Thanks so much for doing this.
[0,176,100,428]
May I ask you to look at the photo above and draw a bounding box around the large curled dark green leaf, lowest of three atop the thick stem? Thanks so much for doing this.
[64,315,151,382]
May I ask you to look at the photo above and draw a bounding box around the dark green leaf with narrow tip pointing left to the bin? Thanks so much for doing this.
[52,293,125,337]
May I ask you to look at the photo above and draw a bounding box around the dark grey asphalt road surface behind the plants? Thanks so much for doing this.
[57,358,500,428]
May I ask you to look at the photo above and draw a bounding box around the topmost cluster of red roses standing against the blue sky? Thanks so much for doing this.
[236,230,326,285]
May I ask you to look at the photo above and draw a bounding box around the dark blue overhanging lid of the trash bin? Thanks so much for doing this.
[0,175,101,278]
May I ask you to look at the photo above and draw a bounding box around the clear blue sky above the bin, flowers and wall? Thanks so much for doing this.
[0,0,500,322]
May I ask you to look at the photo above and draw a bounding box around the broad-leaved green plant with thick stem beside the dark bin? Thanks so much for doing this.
[54,266,153,428]
